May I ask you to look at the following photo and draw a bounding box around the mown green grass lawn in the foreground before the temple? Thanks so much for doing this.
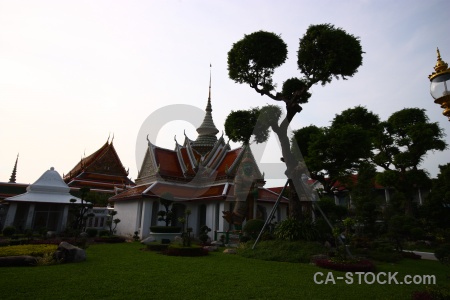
[0,243,449,300]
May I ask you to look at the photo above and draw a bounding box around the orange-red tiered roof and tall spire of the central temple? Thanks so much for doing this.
[109,74,284,202]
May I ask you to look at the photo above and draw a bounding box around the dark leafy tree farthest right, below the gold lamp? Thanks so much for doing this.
[373,108,447,215]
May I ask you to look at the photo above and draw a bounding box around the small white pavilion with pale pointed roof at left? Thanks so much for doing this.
[3,167,81,232]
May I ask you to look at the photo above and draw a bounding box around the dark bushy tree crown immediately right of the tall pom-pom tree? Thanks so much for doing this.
[292,106,380,195]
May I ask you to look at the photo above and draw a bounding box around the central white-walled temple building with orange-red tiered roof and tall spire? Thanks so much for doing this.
[109,77,287,238]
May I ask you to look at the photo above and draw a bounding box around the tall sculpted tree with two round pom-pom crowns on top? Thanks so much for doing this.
[228,24,363,218]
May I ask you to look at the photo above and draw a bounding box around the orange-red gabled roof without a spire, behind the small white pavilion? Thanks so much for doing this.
[64,138,135,193]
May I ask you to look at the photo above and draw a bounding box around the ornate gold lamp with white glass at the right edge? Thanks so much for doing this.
[428,48,450,121]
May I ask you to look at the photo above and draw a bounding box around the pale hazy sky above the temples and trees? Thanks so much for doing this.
[0,0,450,186]
